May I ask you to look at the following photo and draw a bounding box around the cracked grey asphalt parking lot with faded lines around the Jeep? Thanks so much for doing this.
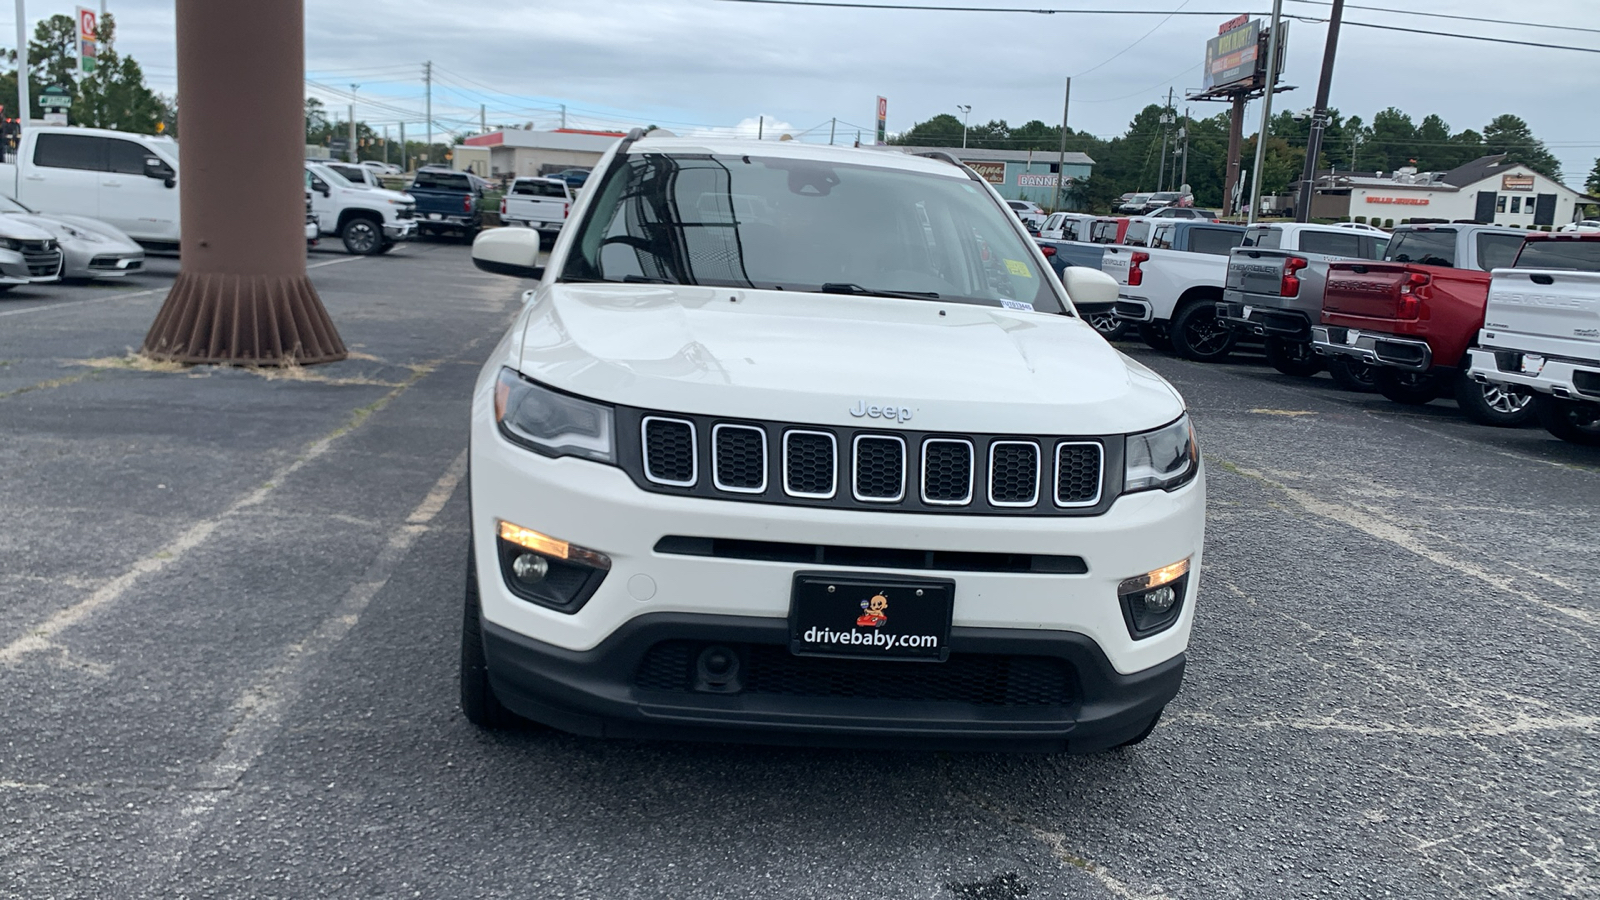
[0,243,1600,900]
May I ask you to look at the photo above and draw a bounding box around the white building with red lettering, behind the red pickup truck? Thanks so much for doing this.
[1310,154,1600,227]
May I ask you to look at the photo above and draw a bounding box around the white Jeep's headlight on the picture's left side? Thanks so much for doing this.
[494,368,616,463]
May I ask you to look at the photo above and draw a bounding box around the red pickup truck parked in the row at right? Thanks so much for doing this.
[1312,224,1533,426]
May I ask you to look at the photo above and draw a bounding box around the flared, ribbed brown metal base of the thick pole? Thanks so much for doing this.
[144,272,349,365]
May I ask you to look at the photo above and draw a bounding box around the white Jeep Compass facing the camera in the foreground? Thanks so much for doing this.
[461,131,1205,753]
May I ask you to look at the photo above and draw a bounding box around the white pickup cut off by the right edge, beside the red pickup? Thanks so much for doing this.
[1467,232,1600,447]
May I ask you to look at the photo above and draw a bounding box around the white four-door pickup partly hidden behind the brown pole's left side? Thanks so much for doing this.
[0,125,178,248]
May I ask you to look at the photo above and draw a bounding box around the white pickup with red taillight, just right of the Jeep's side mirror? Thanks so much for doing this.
[1101,219,1245,362]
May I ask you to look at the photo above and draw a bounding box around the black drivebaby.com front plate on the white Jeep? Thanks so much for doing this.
[789,572,955,660]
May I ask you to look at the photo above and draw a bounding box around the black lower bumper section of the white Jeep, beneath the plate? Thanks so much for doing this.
[483,613,1184,753]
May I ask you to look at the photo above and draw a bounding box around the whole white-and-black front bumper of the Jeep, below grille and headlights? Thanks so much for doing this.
[470,374,1205,739]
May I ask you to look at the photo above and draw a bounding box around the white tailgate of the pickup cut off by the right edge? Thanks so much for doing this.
[1483,269,1600,341]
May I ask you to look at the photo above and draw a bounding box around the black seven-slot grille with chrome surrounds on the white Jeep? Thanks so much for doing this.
[616,407,1125,516]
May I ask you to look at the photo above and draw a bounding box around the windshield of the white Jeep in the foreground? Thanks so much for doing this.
[562,154,1062,312]
